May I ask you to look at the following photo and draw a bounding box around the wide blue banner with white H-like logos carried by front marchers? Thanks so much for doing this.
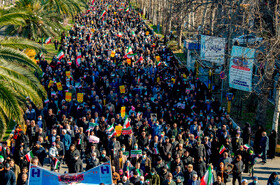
[29,162,113,185]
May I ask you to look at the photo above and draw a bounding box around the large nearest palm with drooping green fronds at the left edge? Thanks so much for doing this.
[0,35,46,139]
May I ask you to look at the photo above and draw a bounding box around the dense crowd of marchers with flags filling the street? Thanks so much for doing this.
[0,0,278,185]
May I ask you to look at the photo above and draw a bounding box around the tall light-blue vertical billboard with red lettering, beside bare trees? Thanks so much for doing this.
[229,46,256,92]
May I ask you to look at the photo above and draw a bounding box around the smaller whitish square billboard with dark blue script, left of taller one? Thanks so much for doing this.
[200,35,226,65]
